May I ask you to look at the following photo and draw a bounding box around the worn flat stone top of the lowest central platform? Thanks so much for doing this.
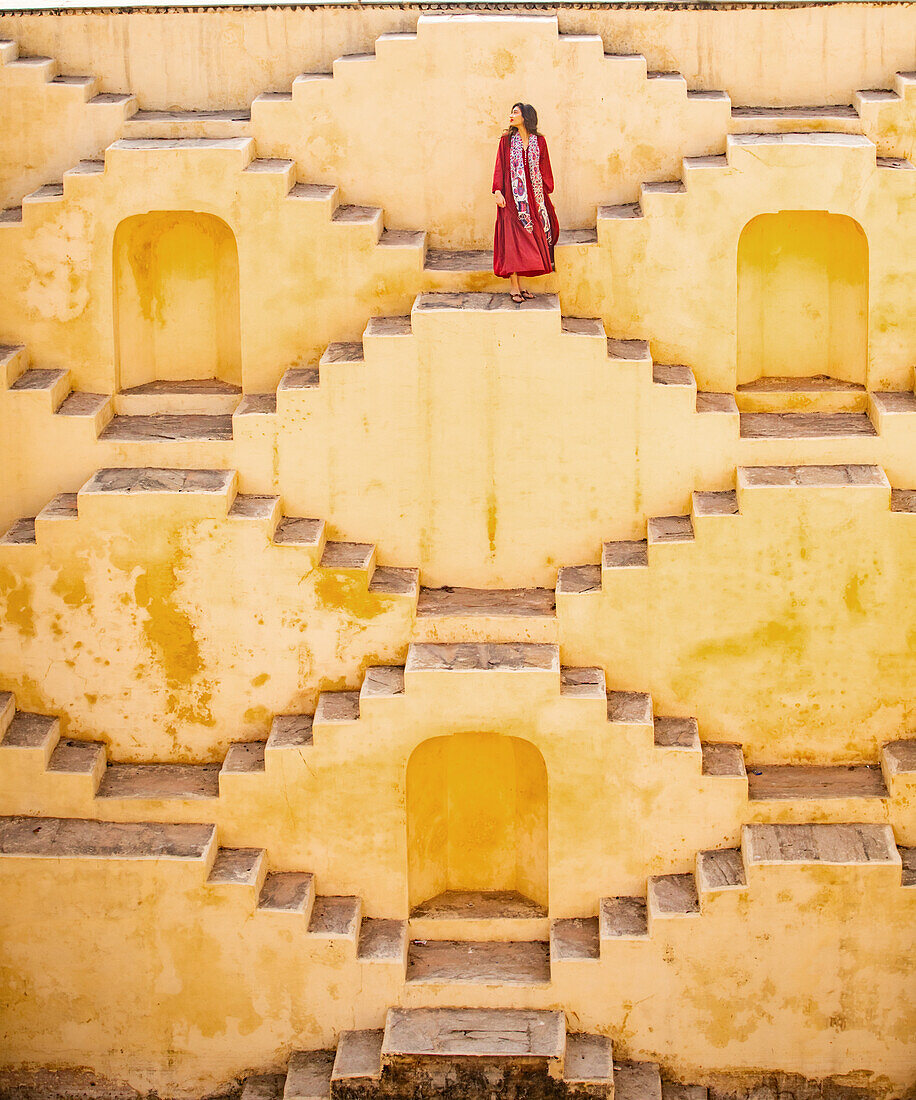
[383,1008,566,1062]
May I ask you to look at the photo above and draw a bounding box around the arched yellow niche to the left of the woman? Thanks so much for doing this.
[113,210,242,389]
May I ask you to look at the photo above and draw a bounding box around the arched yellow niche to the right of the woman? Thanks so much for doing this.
[738,210,869,385]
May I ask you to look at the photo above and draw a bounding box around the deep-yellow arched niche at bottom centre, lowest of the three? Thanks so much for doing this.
[407,733,548,910]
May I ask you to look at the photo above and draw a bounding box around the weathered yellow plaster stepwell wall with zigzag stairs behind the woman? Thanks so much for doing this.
[0,2,916,1100]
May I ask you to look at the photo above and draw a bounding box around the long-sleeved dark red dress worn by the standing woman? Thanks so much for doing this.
[493,134,560,278]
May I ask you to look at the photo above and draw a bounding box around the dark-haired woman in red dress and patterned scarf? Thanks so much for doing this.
[493,103,560,304]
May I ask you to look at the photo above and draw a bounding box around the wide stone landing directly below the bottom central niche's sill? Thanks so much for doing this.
[407,939,550,986]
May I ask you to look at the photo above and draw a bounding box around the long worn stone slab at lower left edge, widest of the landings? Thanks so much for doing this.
[0,817,217,867]
